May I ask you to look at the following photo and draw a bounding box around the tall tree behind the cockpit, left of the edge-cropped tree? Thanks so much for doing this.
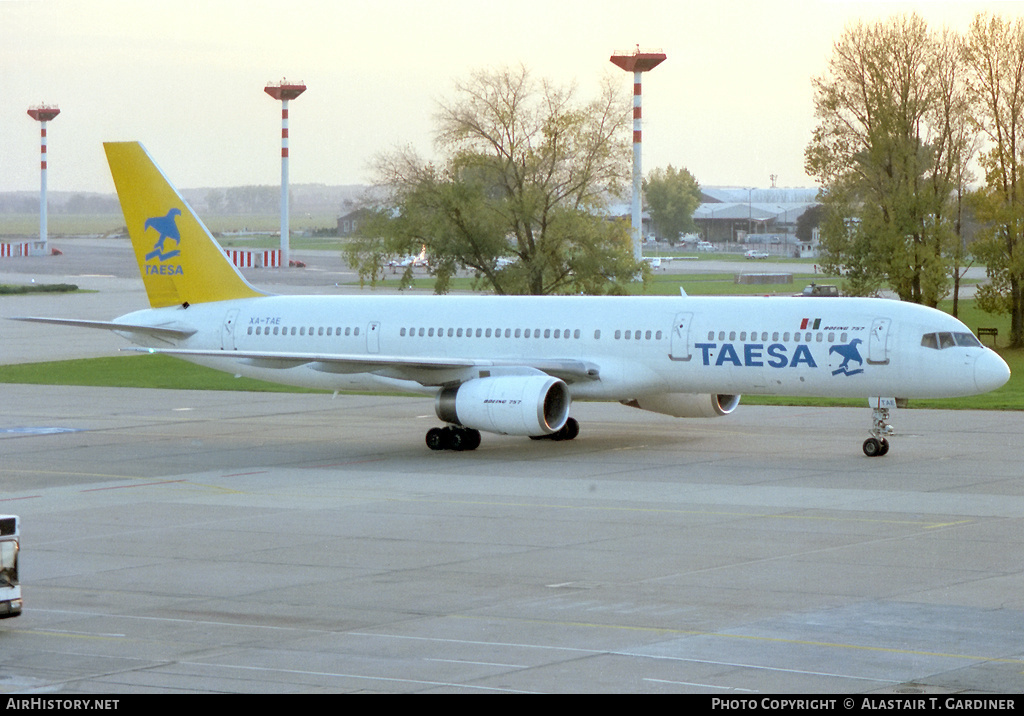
[805,14,970,306]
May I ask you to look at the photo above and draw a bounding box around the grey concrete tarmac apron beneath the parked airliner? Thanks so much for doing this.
[0,242,1024,697]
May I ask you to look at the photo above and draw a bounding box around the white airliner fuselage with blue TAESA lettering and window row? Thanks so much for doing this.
[118,296,1009,401]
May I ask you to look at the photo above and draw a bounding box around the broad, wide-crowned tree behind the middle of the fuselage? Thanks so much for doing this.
[348,67,642,294]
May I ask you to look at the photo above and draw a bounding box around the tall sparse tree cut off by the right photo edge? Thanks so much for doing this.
[965,14,1024,347]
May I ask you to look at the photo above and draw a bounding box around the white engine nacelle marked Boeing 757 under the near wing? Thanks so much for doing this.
[435,375,571,435]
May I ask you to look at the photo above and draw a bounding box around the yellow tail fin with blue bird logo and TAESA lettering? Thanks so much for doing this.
[103,141,263,308]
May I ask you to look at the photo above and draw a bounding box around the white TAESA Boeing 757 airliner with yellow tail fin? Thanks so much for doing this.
[9,142,1010,457]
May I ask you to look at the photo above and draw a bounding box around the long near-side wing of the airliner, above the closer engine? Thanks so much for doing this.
[124,348,600,385]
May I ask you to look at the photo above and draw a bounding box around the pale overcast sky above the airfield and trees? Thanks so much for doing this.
[0,0,1024,192]
